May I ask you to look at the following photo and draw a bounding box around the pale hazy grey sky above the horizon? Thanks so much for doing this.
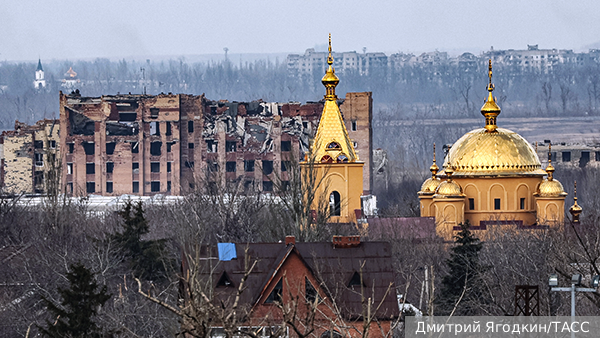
[0,0,600,60]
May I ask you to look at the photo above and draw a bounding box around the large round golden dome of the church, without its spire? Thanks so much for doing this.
[444,128,545,176]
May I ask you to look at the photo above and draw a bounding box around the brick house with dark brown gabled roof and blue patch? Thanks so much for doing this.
[185,236,400,337]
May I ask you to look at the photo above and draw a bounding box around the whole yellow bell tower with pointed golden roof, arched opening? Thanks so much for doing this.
[301,34,364,223]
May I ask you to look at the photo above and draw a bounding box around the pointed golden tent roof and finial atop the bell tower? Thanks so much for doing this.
[312,34,358,163]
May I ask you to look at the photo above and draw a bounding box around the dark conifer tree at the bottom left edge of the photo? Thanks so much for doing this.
[39,263,111,338]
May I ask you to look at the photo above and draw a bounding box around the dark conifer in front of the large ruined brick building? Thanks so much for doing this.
[113,200,170,280]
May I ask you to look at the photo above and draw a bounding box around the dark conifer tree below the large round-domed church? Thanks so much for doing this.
[437,221,489,316]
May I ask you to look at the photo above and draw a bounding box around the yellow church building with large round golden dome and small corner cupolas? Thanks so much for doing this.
[418,60,567,237]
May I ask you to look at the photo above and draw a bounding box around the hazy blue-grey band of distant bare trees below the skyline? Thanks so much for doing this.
[0,57,600,128]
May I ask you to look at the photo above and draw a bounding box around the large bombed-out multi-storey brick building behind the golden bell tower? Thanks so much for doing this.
[60,91,372,196]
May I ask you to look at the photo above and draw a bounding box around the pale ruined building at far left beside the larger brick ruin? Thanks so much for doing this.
[1,120,60,195]
